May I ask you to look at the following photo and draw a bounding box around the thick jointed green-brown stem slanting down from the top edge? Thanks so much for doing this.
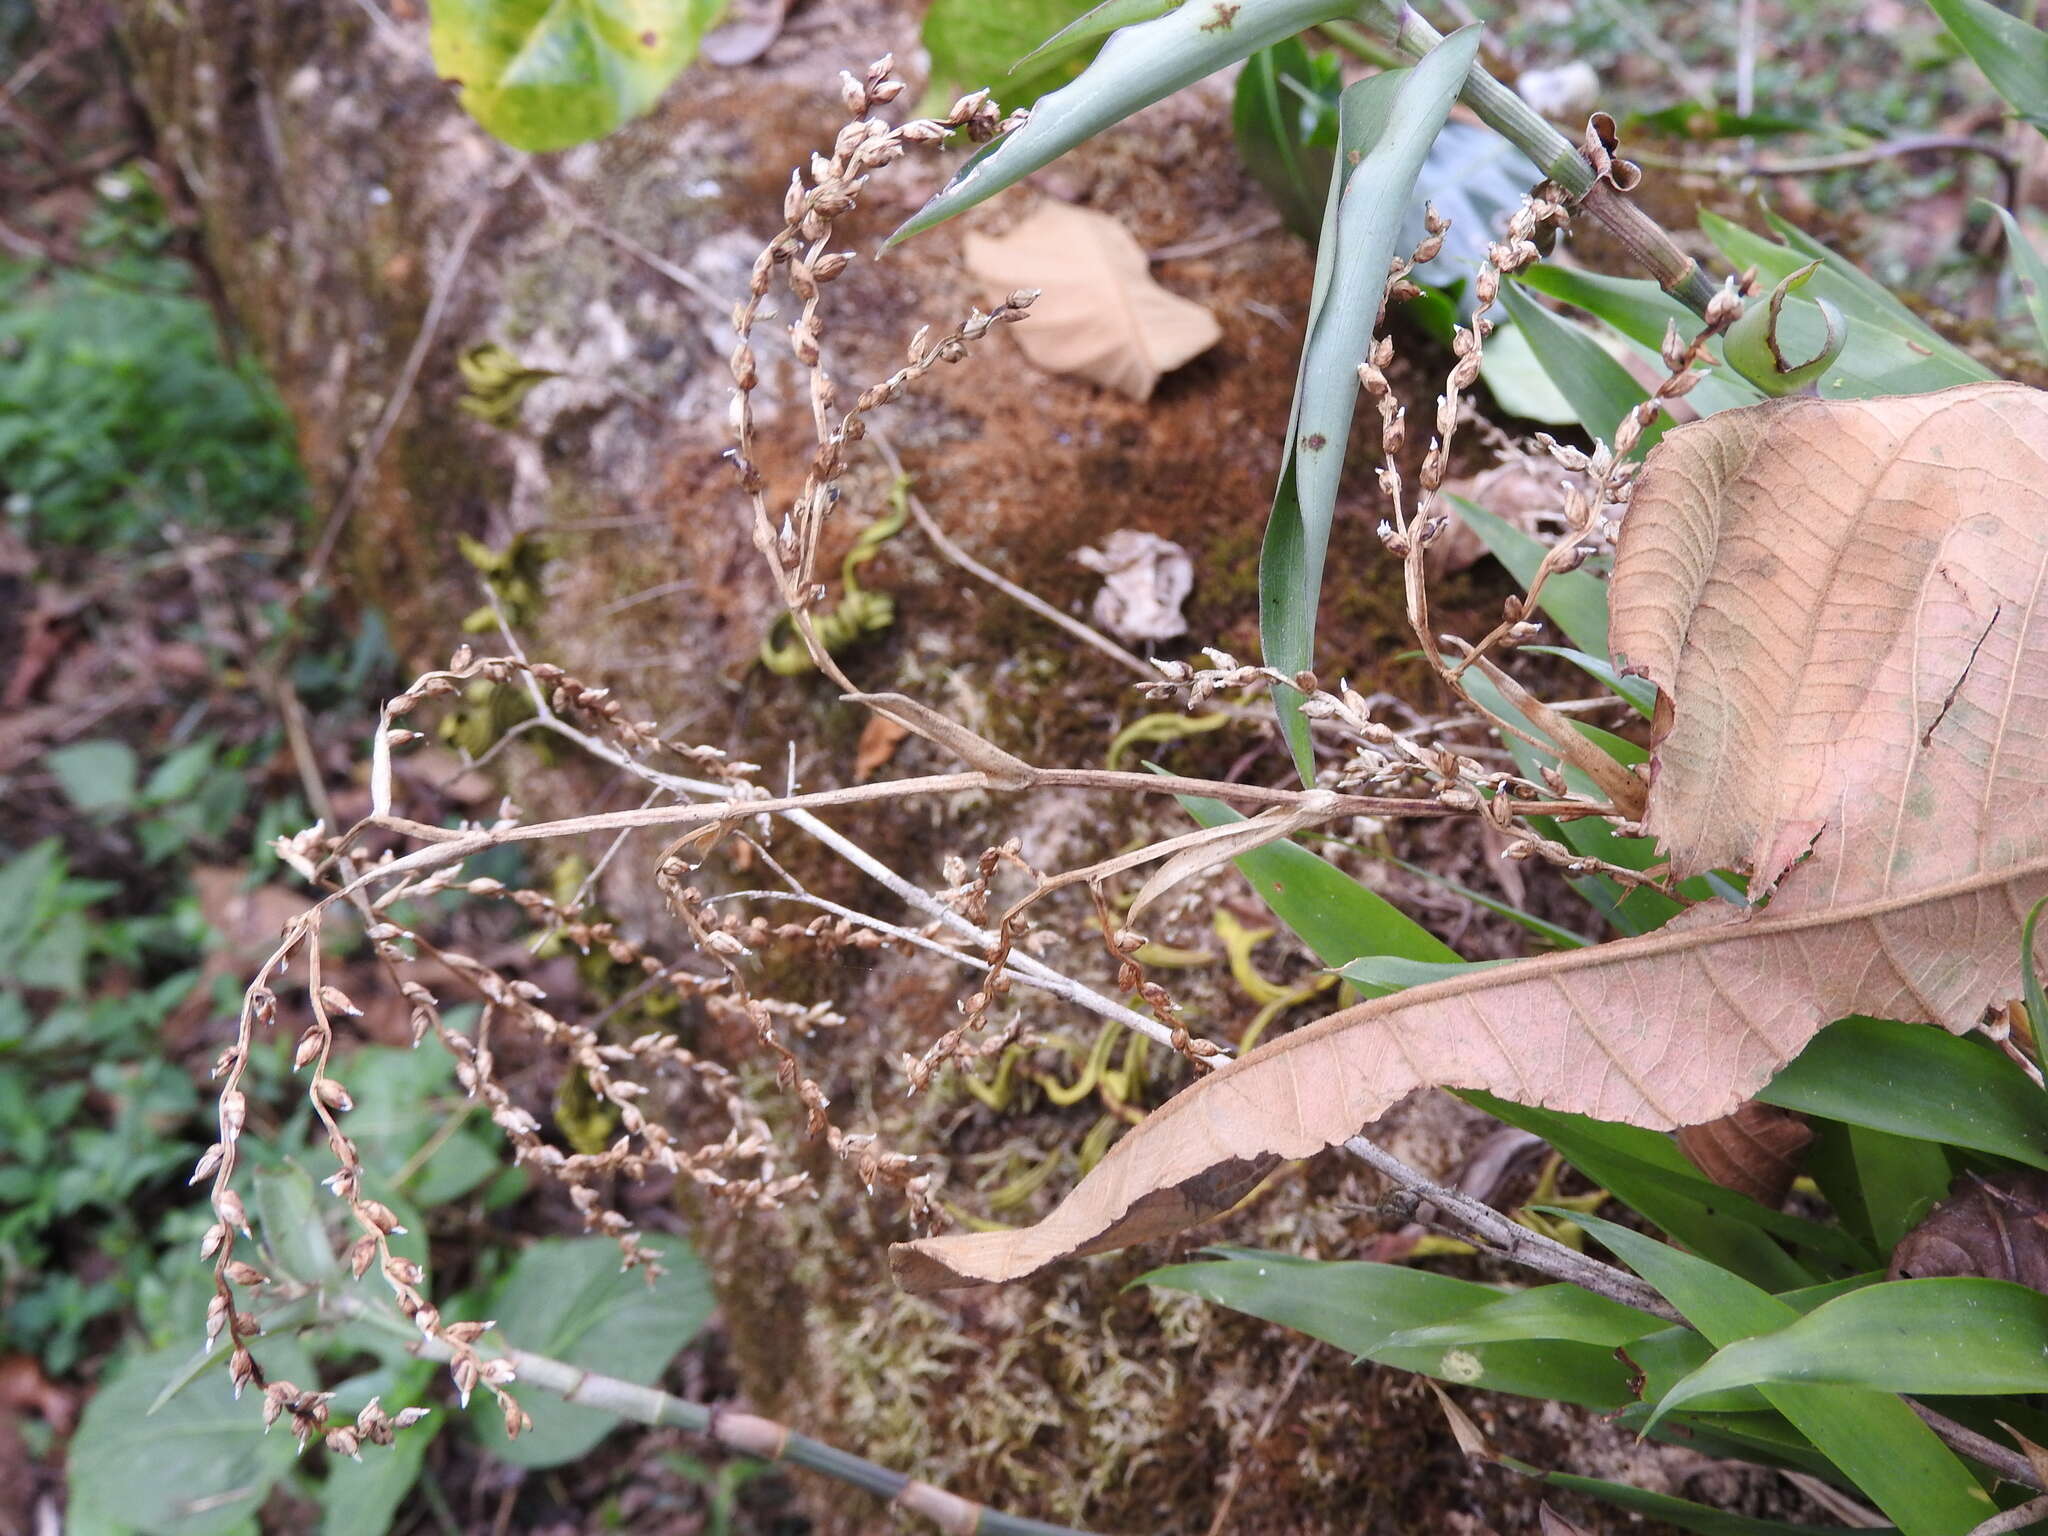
[1360,0,1714,317]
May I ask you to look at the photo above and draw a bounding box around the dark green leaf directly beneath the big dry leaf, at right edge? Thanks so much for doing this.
[1757,1018,2048,1167]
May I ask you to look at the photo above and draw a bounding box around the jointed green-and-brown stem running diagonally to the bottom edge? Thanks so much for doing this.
[319,1292,1087,1536]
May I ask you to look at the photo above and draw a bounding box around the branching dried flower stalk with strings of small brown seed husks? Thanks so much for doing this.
[195,48,1741,1482]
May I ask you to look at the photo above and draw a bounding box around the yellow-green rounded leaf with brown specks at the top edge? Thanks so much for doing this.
[430,0,723,150]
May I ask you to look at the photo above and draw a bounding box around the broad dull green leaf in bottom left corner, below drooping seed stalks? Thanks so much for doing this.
[66,1325,315,1536]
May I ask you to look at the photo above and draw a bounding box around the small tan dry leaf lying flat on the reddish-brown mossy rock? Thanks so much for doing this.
[961,203,1223,399]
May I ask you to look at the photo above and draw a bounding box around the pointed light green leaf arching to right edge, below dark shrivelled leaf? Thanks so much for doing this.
[1657,1276,2048,1413]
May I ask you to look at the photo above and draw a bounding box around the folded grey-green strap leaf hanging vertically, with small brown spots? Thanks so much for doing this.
[1260,27,1481,782]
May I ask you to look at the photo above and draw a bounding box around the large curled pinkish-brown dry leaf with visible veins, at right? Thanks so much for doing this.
[891,385,2048,1290]
